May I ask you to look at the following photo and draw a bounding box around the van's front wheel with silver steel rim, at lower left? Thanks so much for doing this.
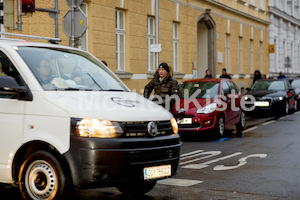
[18,151,66,200]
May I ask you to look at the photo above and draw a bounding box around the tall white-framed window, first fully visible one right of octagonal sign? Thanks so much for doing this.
[116,10,125,72]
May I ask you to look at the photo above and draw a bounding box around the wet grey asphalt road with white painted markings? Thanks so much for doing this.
[0,112,300,200]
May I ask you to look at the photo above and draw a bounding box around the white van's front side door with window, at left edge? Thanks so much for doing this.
[0,50,26,181]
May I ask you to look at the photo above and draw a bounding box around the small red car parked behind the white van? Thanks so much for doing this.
[173,79,245,136]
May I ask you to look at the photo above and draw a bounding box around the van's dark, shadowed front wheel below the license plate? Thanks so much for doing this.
[117,180,156,195]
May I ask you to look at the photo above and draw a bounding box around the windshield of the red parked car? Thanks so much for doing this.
[179,82,220,99]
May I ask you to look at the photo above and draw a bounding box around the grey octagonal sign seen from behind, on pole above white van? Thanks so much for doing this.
[63,9,87,37]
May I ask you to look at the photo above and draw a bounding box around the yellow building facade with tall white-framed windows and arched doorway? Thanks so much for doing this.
[1,0,269,93]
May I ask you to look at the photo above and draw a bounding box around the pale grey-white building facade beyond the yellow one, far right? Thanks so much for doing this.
[269,0,300,77]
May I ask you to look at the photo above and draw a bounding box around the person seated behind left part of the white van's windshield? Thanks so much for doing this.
[35,57,53,85]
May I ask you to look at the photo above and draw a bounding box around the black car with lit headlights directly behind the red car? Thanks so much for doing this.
[244,79,297,115]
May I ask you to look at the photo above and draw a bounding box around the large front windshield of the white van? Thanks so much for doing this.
[15,46,129,91]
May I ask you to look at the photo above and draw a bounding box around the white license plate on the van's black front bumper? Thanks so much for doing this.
[144,165,171,180]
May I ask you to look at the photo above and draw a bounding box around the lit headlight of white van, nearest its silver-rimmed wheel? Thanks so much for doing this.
[75,119,123,138]
